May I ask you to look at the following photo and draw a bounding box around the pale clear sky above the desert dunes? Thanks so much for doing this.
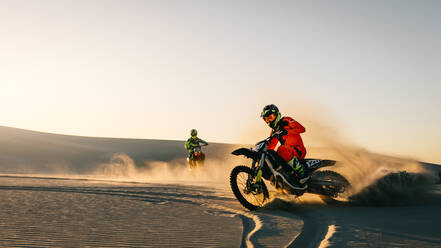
[0,0,441,163]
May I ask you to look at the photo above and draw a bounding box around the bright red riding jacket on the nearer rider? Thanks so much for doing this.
[268,116,306,161]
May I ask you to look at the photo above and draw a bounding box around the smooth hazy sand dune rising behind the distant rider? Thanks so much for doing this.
[0,126,232,173]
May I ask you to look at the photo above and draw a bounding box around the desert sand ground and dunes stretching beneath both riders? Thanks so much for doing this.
[0,127,441,247]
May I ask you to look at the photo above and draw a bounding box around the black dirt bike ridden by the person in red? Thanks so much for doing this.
[230,132,350,211]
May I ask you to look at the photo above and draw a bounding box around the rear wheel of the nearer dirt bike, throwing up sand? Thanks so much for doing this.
[310,170,351,204]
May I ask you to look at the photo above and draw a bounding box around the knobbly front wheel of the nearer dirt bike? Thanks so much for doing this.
[230,165,269,211]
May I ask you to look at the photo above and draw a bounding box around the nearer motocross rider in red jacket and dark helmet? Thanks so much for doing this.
[261,104,310,188]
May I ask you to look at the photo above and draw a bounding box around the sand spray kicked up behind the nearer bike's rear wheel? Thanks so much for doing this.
[304,120,437,206]
